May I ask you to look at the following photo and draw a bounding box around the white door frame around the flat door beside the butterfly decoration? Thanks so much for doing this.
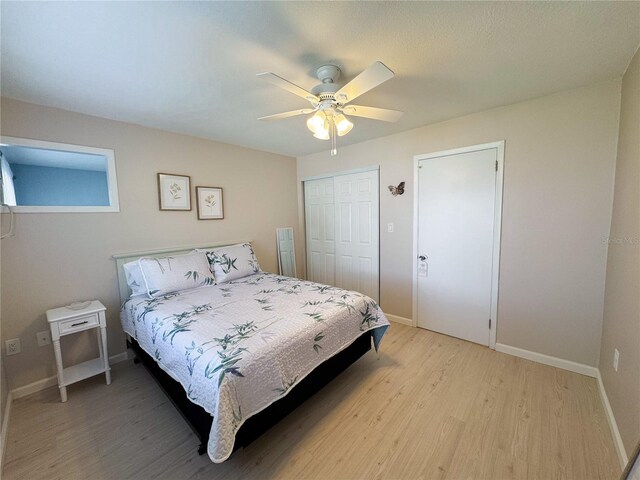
[412,140,505,350]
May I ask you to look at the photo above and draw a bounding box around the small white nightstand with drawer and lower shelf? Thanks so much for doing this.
[47,300,111,402]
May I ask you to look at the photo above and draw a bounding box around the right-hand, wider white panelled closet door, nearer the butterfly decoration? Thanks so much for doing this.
[334,170,379,301]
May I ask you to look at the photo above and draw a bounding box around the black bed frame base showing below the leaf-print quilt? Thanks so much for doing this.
[127,331,371,455]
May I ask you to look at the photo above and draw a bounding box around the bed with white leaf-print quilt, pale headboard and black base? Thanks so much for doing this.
[115,243,389,463]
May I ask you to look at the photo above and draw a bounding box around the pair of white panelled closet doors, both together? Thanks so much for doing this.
[304,170,379,301]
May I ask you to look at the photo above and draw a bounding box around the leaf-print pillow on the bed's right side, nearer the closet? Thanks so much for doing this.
[200,243,262,283]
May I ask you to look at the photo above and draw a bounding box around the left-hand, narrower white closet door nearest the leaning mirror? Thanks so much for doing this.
[304,178,336,285]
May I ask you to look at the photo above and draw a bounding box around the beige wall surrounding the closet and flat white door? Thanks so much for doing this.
[298,81,620,366]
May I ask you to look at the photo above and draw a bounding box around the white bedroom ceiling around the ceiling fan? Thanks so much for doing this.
[0,1,640,156]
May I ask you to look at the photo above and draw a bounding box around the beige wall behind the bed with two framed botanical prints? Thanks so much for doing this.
[1,98,301,388]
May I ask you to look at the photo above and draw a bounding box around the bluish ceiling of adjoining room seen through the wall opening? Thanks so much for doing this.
[0,145,107,172]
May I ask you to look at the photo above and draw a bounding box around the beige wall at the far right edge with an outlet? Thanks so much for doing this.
[600,50,640,455]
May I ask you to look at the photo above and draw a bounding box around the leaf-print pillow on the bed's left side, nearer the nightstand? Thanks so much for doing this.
[138,252,216,298]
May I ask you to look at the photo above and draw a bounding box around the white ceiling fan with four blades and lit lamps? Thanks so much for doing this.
[257,62,403,155]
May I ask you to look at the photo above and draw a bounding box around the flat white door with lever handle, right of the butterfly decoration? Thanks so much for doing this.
[417,148,497,345]
